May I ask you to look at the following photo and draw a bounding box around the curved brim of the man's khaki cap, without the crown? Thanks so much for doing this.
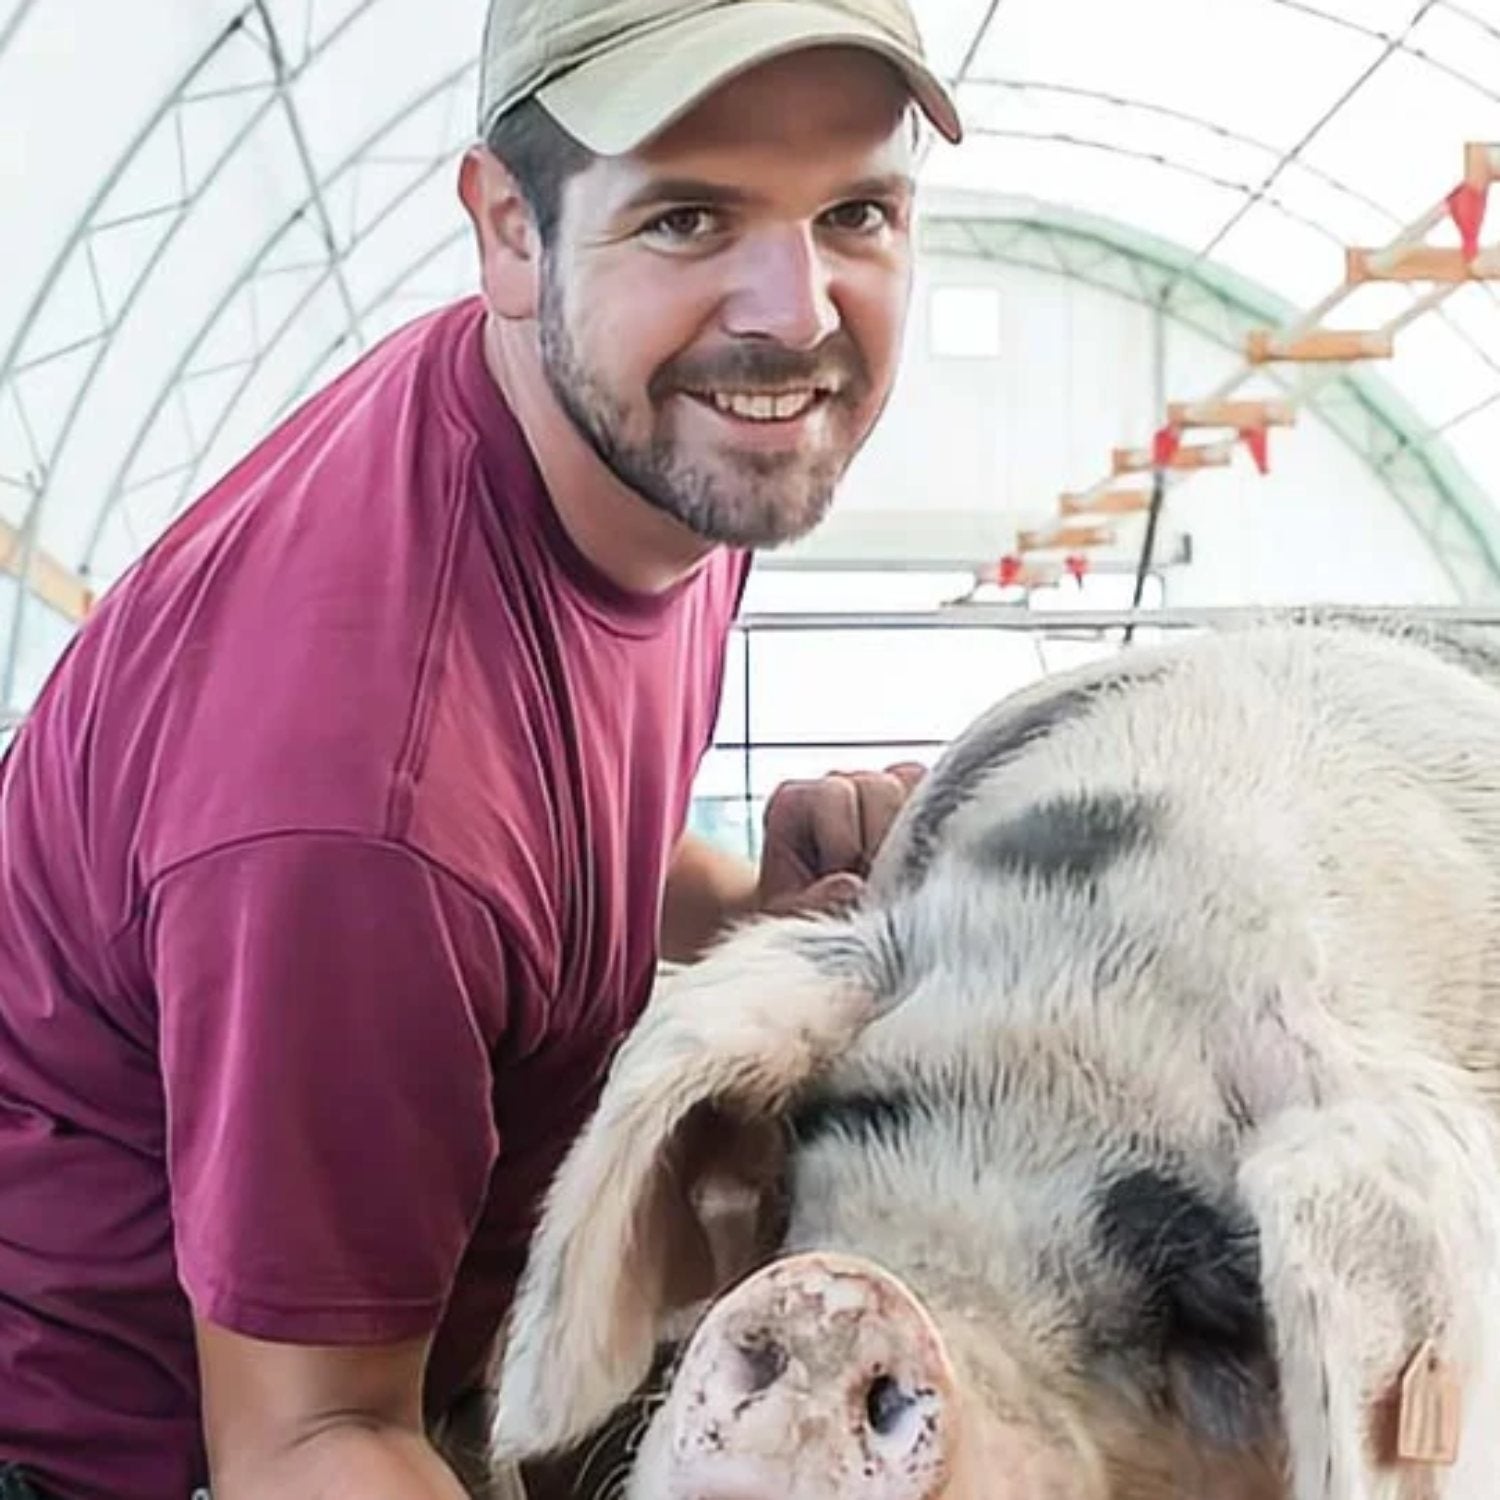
[537,0,963,156]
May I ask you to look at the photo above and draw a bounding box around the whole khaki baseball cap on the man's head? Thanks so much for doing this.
[479,0,963,156]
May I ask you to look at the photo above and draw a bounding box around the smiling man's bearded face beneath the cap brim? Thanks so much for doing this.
[540,50,912,548]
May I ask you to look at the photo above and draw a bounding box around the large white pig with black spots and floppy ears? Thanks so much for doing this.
[492,617,1500,1500]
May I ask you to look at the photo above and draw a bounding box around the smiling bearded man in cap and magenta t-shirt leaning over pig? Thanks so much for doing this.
[0,0,959,1500]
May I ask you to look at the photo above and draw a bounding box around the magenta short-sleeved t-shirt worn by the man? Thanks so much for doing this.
[0,302,749,1500]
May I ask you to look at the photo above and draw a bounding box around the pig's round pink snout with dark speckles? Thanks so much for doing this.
[666,1254,957,1500]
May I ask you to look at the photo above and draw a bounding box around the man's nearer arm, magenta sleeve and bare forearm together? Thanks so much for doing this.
[149,836,513,1500]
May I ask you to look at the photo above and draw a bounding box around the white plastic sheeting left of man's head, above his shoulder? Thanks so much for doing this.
[0,0,482,582]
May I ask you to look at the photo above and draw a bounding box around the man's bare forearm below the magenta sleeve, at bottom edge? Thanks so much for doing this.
[197,1322,464,1500]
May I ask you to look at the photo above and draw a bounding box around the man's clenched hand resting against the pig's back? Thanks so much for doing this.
[756,762,926,915]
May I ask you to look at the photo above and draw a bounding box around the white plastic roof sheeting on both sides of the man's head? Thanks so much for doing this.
[0,0,1500,621]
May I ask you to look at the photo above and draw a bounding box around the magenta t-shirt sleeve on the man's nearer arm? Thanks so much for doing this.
[147,834,516,1344]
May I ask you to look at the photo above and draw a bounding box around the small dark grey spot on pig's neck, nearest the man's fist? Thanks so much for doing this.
[975,792,1164,885]
